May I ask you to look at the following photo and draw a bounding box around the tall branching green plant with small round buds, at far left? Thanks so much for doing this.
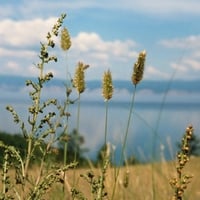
[0,14,77,200]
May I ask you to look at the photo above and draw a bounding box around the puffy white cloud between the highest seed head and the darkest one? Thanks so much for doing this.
[72,32,138,67]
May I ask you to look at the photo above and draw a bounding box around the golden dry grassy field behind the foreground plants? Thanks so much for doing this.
[38,158,200,200]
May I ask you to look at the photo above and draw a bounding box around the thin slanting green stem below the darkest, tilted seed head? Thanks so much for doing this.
[111,85,136,200]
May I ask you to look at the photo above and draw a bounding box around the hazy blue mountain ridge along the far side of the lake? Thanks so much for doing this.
[0,75,200,93]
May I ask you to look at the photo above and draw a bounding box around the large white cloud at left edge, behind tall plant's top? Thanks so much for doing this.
[0,17,57,47]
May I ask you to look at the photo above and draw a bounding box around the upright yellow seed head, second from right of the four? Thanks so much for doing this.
[102,70,113,101]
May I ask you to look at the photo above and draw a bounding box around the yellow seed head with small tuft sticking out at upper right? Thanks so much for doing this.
[73,62,89,94]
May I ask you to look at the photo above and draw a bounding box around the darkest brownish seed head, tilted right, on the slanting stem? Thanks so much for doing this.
[132,51,146,86]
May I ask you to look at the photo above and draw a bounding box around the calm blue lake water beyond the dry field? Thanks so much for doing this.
[0,102,200,163]
